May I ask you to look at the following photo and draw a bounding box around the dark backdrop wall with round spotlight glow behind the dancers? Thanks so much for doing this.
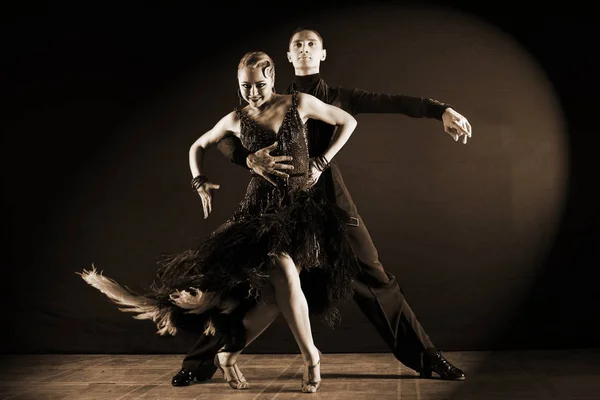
[1,1,600,353]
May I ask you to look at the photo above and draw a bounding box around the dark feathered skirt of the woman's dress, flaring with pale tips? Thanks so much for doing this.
[80,180,359,335]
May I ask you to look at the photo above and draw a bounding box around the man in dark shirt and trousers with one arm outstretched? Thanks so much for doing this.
[172,29,471,386]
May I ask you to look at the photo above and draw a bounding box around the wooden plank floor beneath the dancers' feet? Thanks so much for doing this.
[0,349,600,400]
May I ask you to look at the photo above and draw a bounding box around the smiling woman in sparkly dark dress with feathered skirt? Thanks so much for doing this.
[82,52,357,393]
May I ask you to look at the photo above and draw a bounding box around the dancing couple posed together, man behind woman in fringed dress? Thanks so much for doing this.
[81,29,471,393]
